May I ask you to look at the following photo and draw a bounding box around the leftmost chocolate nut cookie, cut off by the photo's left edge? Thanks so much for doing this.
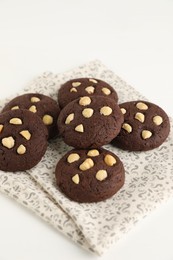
[0,109,48,172]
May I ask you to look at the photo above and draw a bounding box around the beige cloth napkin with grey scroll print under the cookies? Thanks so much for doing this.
[0,61,173,255]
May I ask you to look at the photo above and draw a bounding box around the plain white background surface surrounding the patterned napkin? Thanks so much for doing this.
[0,0,173,260]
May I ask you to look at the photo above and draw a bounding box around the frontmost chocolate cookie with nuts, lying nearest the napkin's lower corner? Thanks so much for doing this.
[55,148,125,202]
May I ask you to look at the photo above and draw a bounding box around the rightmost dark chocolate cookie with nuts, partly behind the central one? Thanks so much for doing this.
[112,100,170,151]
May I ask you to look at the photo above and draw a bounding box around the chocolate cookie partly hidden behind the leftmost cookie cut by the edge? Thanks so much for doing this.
[2,93,60,139]
